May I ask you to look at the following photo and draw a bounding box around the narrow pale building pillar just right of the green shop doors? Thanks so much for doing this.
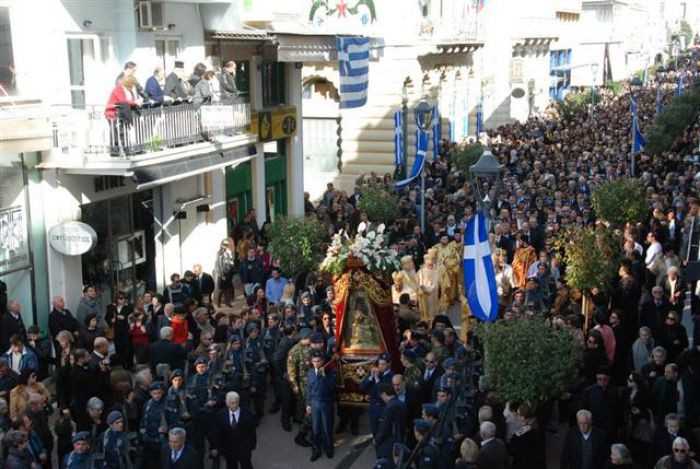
[287,63,304,217]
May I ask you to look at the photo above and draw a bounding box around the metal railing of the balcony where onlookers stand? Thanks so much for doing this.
[53,103,250,159]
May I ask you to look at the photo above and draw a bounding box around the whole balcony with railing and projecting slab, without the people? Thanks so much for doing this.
[42,103,257,186]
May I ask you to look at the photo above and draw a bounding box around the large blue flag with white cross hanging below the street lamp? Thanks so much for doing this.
[464,211,498,322]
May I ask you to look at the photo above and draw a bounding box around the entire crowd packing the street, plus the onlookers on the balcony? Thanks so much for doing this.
[0,59,700,469]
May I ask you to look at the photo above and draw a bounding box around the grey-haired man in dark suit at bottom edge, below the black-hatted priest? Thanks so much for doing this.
[559,410,608,469]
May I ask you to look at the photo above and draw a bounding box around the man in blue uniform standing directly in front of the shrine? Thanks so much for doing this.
[306,350,335,461]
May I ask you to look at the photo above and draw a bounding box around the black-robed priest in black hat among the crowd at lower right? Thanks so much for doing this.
[582,367,622,443]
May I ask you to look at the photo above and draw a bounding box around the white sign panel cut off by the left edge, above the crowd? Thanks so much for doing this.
[0,207,30,273]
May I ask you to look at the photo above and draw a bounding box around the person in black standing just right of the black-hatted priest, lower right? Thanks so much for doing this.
[623,372,654,467]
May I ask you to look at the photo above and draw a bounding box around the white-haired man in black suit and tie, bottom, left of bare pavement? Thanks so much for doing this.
[210,391,258,469]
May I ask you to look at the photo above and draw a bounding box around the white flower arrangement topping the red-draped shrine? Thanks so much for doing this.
[320,223,401,275]
